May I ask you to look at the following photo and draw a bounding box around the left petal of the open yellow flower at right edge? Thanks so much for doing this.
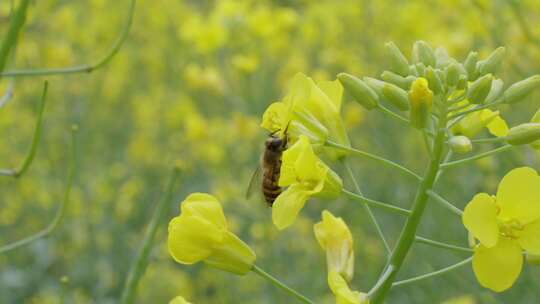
[463,193,499,247]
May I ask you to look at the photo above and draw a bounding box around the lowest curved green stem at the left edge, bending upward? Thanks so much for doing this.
[0,128,77,254]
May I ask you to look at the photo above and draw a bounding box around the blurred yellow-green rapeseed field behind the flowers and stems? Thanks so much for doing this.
[0,0,540,303]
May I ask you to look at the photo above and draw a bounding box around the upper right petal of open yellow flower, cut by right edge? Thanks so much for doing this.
[497,167,540,225]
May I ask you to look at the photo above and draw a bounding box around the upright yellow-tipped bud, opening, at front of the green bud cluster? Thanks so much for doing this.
[409,77,433,129]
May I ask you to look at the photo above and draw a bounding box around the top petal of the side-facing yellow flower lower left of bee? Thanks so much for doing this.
[180,192,227,229]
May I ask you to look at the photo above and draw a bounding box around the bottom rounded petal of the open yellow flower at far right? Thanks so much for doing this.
[473,237,523,292]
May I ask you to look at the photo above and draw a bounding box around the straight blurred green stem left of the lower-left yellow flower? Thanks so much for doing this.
[121,167,180,304]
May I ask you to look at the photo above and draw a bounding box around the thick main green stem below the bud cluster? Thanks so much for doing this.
[371,109,446,304]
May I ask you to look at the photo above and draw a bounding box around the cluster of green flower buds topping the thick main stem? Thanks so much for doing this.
[338,41,540,135]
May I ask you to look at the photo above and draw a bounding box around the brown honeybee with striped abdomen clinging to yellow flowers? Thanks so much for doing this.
[246,129,288,207]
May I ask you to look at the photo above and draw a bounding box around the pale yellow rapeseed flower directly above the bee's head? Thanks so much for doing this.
[261,73,350,151]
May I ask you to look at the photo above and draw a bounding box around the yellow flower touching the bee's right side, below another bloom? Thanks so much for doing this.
[272,135,343,229]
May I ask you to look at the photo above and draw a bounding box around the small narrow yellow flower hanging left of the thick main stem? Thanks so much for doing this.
[313,210,354,281]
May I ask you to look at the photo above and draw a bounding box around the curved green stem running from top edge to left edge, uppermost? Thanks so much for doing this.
[0,0,136,77]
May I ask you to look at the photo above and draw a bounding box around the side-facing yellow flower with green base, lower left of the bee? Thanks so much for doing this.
[168,193,255,274]
